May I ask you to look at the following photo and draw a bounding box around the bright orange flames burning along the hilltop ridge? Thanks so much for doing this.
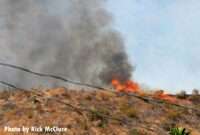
[112,79,177,103]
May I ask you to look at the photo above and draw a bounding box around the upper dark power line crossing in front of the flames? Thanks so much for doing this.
[0,62,200,112]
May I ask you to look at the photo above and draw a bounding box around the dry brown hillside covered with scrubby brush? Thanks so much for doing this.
[0,87,200,135]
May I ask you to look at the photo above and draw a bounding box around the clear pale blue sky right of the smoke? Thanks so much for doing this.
[107,0,200,93]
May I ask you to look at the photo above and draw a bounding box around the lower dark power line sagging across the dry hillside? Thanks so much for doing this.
[0,81,162,133]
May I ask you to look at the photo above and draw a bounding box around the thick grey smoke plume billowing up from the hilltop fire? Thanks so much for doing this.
[0,0,132,88]
